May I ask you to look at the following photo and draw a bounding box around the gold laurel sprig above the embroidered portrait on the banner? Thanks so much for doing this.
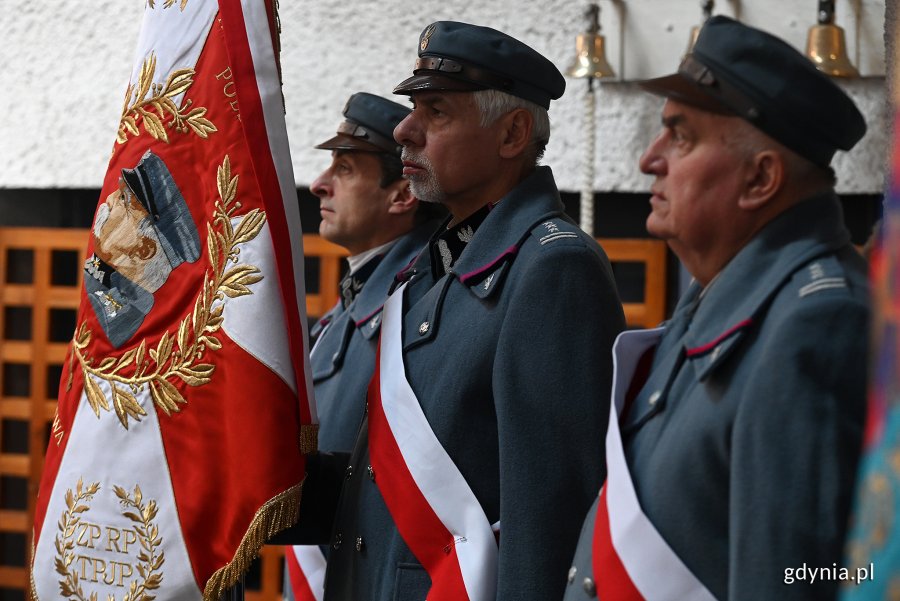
[116,52,218,144]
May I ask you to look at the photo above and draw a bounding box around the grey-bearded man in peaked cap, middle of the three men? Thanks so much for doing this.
[318,22,624,601]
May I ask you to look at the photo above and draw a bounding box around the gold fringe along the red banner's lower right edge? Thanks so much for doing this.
[203,478,305,601]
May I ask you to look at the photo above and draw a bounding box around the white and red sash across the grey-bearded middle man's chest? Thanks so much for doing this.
[369,285,497,601]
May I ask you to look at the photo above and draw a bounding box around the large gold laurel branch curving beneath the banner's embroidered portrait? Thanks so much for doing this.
[72,155,266,430]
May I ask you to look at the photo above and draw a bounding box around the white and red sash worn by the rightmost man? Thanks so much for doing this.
[593,328,715,601]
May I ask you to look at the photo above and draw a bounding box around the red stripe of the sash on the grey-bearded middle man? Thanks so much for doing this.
[369,346,469,601]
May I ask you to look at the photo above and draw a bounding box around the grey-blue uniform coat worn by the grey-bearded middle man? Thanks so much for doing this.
[324,167,624,601]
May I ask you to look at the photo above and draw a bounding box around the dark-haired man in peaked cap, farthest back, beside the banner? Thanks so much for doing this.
[276,92,441,599]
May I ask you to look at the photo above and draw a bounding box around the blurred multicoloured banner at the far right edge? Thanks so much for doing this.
[844,16,900,601]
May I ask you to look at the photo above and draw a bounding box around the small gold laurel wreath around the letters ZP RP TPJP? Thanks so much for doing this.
[55,478,166,601]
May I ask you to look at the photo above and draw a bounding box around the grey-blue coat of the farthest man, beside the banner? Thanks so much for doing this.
[310,221,438,452]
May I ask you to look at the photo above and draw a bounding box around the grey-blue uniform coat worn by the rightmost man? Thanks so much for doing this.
[565,194,869,601]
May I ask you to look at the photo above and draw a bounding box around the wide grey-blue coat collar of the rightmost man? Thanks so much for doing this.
[676,193,850,352]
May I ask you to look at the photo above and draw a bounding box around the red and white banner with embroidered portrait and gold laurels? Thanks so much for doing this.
[32,0,315,601]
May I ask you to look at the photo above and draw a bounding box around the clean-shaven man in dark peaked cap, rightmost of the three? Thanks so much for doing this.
[565,17,869,601]
